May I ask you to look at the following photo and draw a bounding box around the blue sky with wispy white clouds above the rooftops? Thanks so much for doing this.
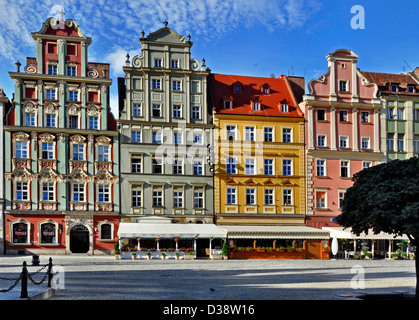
[0,0,419,116]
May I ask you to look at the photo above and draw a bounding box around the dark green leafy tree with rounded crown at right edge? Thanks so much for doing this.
[336,157,419,298]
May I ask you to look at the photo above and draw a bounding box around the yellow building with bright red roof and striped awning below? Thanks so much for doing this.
[210,74,328,255]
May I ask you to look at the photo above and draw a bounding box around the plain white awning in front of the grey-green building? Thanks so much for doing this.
[118,222,226,239]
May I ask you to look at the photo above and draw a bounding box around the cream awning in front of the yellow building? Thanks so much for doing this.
[219,225,330,240]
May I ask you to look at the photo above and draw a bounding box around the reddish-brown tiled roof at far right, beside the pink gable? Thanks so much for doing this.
[361,71,419,95]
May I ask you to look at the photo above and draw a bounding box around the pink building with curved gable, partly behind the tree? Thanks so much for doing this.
[300,49,384,228]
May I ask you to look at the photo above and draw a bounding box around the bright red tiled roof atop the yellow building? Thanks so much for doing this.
[210,74,304,117]
